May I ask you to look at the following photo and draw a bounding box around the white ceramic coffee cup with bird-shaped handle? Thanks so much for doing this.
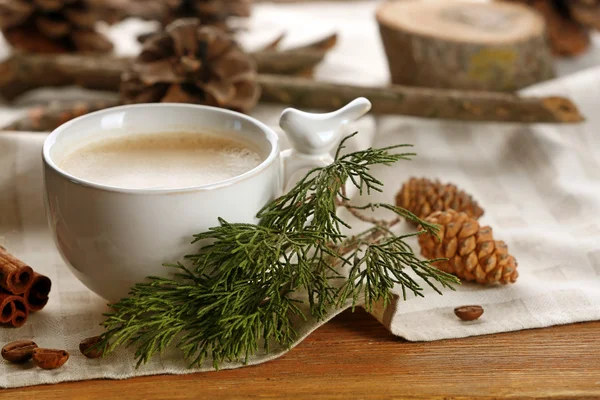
[42,98,371,302]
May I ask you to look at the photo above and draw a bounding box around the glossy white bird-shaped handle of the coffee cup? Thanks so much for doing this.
[279,97,371,188]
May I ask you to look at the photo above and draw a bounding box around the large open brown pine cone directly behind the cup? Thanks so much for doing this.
[121,19,260,112]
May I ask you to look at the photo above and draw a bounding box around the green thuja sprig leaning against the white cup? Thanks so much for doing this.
[98,134,457,368]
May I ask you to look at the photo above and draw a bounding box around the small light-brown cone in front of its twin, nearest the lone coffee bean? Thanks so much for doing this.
[419,210,519,284]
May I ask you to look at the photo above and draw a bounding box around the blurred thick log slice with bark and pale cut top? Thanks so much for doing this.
[376,0,554,91]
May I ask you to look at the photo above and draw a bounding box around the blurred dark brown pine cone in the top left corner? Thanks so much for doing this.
[0,0,113,53]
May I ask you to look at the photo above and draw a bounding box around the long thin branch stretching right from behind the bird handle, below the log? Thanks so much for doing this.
[258,75,584,123]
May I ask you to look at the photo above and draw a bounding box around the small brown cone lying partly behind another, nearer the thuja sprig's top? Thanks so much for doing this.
[396,178,483,219]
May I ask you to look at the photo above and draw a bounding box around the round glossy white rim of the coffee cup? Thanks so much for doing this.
[42,103,279,194]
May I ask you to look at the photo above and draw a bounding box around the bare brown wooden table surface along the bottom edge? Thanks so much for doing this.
[0,311,600,400]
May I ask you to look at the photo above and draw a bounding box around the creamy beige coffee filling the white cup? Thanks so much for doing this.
[59,132,263,189]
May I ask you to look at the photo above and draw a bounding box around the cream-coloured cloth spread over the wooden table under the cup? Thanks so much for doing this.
[0,2,600,387]
